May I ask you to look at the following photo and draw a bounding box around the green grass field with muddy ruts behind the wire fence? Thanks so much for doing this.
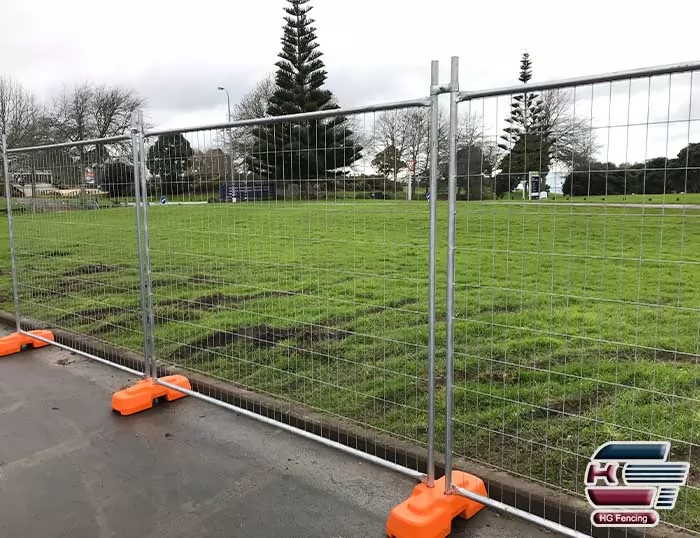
[0,201,700,530]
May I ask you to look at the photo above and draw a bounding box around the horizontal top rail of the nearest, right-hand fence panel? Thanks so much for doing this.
[459,61,700,102]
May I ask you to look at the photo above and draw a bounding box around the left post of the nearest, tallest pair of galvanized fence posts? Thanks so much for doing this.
[426,60,440,488]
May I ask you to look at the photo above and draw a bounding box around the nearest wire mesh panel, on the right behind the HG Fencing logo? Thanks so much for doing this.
[454,68,700,532]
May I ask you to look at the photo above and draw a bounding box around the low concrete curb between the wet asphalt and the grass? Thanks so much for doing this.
[0,311,692,538]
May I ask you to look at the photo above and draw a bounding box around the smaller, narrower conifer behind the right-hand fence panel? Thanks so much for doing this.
[496,52,553,194]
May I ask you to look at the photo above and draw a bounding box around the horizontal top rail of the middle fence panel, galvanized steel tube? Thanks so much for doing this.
[144,97,431,136]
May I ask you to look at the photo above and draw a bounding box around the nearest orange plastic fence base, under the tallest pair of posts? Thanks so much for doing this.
[386,471,487,538]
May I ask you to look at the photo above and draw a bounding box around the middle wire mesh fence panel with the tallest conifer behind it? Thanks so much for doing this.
[138,107,438,464]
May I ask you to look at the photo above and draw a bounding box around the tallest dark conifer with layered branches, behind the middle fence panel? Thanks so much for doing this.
[246,0,362,181]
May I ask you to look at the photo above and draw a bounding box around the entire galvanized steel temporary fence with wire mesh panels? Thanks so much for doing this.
[3,59,700,536]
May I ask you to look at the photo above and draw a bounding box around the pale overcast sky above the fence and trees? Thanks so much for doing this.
[0,0,700,163]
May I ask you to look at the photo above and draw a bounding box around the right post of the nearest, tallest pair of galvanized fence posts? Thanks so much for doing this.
[445,56,459,495]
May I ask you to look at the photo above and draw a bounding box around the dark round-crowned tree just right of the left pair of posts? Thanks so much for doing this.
[146,133,194,194]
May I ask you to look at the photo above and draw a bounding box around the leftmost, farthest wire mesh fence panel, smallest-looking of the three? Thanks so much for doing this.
[2,139,143,368]
